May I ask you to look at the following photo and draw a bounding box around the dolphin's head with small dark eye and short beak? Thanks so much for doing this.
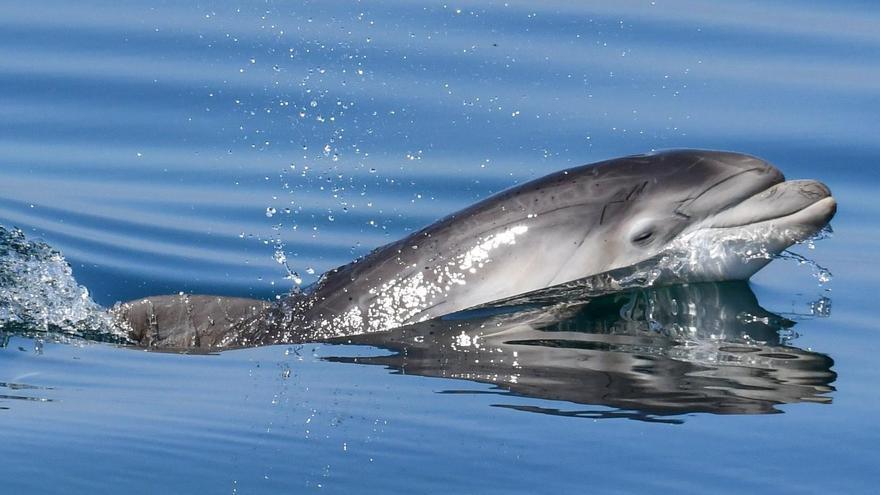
[568,150,836,282]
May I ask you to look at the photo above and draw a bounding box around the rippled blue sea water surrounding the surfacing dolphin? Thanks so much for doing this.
[0,0,880,493]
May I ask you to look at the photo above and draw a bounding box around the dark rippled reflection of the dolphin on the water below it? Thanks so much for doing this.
[328,282,837,422]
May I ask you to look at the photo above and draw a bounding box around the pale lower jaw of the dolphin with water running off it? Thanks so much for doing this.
[658,190,837,282]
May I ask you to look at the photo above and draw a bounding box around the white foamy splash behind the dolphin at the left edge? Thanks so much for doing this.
[0,227,125,341]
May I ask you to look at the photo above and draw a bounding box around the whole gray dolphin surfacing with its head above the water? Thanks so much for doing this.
[113,150,836,349]
